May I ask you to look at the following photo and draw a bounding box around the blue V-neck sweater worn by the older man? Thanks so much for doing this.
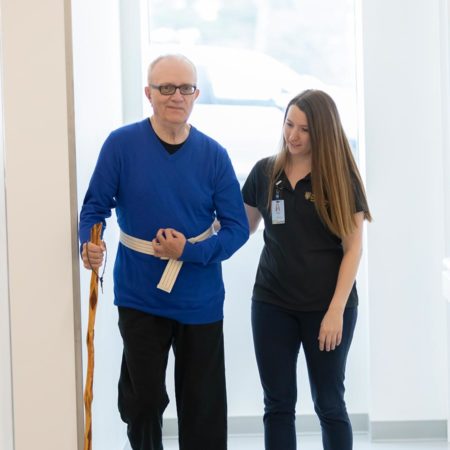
[79,119,249,324]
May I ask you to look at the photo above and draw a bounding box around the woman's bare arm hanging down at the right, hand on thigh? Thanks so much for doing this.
[319,212,364,351]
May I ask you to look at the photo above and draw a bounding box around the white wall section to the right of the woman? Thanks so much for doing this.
[362,0,449,423]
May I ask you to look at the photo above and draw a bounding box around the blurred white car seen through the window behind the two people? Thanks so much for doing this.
[146,44,354,181]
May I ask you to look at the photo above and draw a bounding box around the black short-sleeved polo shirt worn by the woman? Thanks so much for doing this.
[242,158,365,311]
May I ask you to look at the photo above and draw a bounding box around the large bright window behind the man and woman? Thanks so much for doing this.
[144,0,357,180]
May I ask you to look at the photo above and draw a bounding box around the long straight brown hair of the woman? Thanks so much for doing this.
[267,89,372,237]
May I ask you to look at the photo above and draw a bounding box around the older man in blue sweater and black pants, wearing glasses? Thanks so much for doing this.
[80,55,249,450]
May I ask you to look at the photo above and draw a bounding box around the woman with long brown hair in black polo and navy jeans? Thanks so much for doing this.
[242,90,371,450]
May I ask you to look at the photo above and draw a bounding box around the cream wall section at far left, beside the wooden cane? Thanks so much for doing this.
[0,0,80,450]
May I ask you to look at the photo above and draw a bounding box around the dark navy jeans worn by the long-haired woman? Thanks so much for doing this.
[252,301,358,450]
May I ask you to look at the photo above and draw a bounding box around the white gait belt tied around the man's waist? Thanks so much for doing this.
[120,225,214,293]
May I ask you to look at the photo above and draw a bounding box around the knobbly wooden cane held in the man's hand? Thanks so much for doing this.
[84,223,102,450]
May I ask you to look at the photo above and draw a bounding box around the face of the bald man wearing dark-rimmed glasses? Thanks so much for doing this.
[145,57,199,126]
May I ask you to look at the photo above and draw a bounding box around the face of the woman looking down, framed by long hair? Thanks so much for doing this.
[283,105,311,157]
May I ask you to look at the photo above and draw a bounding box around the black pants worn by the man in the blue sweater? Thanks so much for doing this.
[119,307,227,450]
